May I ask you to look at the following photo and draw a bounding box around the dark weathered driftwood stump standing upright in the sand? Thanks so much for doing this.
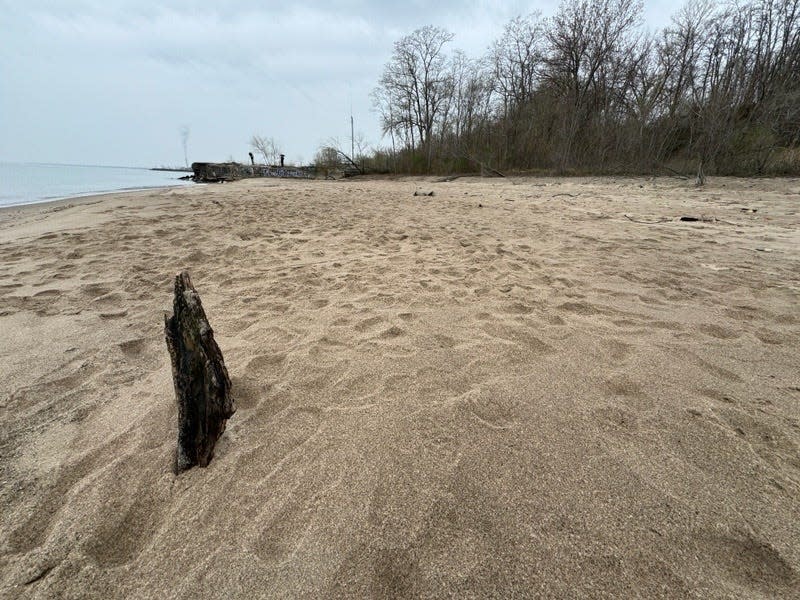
[164,271,236,473]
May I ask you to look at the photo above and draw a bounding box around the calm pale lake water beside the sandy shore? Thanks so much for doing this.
[0,162,192,206]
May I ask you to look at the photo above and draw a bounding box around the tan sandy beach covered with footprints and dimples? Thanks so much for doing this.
[0,178,800,598]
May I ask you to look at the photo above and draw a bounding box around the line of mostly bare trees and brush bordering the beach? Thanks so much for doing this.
[368,0,800,175]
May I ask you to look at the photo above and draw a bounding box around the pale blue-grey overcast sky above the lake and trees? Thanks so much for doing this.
[0,0,679,167]
